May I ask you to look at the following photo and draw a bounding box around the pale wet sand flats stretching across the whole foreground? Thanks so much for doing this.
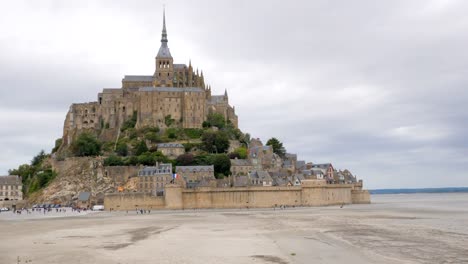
[0,194,468,264]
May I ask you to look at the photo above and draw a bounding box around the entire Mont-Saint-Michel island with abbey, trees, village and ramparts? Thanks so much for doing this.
[2,9,370,208]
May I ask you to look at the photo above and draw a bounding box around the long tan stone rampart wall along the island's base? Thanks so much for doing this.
[104,180,370,210]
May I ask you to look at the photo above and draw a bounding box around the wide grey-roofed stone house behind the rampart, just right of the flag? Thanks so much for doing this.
[176,165,216,187]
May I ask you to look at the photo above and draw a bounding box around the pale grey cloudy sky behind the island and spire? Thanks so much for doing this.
[0,0,468,188]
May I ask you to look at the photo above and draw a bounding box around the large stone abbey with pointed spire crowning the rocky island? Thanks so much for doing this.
[63,10,238,145]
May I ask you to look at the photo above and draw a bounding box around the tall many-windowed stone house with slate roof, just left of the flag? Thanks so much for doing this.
[138,163,173,195]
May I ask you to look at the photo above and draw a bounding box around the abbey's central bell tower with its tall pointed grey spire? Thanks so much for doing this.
[153,9,174,87]
